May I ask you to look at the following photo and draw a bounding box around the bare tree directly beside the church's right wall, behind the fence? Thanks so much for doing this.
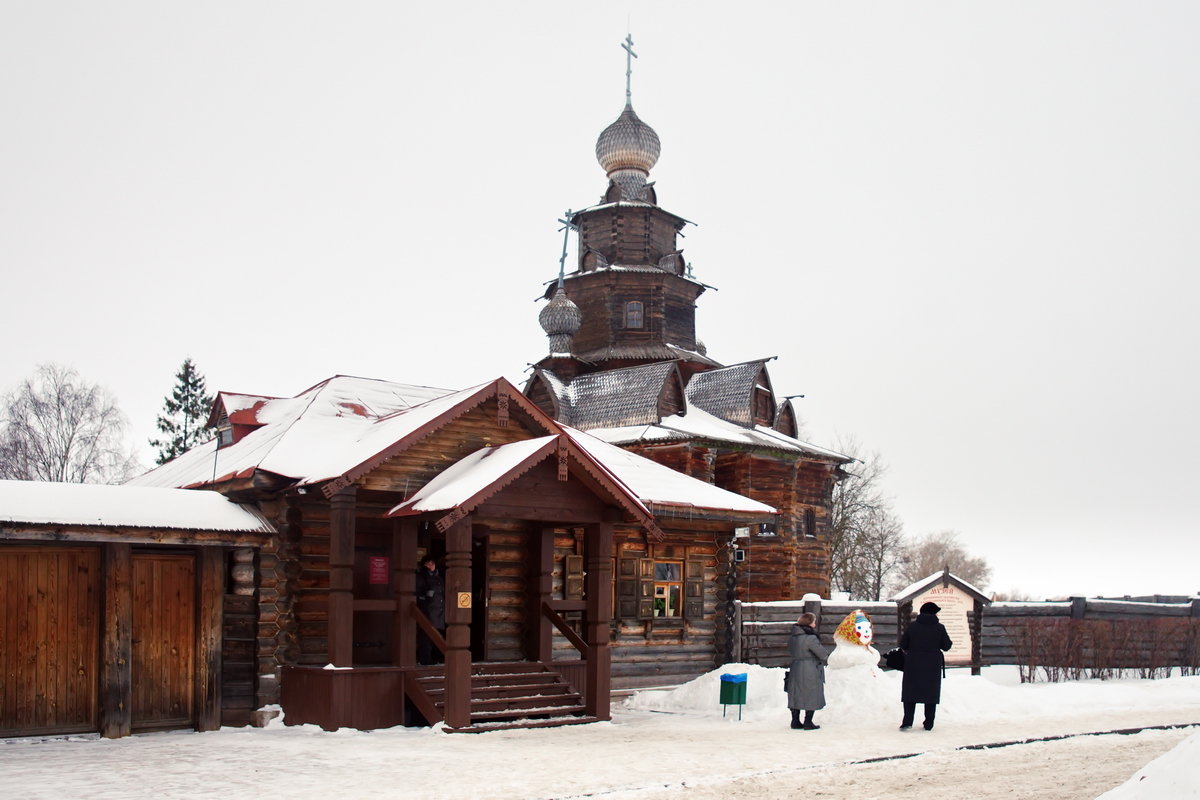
[829,439,905,600]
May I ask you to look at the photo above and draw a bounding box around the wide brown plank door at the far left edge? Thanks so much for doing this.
[0,545,101,736]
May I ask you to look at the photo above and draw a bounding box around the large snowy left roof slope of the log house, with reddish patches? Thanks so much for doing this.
[130,375,460,487]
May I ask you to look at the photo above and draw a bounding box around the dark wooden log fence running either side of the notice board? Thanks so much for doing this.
[733,597,1200,679]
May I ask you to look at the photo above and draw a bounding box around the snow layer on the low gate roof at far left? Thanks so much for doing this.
[0,481,275,534]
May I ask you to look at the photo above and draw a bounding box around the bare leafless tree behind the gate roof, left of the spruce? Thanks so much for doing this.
[0,363,138,483]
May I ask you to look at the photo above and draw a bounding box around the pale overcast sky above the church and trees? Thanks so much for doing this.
[0,0,1200,597]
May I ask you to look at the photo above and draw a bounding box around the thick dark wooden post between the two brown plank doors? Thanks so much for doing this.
[100,543,133,739]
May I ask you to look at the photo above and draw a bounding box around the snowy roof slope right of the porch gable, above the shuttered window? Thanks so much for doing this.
[564,426,776,515]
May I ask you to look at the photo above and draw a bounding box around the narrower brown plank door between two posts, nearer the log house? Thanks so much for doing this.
[131,553,196,730]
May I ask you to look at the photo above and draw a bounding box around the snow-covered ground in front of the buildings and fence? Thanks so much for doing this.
[0,666,1200,800]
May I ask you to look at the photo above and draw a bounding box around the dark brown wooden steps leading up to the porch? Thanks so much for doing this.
[416,661,598,733]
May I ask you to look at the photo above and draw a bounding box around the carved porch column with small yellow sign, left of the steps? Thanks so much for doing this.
[445,515,472,728]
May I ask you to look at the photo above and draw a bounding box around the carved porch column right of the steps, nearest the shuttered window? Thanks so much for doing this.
[583,522,612,720]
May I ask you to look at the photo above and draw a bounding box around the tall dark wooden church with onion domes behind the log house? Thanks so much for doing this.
[524,40,852,601]
